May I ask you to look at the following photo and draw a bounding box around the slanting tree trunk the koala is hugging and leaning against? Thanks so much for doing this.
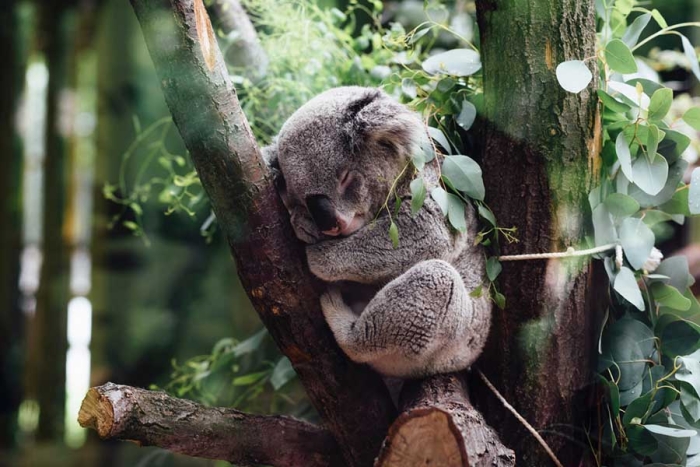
[132,0,395,467]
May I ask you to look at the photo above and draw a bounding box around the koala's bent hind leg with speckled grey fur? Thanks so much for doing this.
[321,260,491,378]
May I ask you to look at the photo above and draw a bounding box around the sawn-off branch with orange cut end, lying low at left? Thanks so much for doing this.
[78,383,343,467]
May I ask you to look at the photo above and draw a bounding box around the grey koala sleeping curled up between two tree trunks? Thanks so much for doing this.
[263,87,491,379]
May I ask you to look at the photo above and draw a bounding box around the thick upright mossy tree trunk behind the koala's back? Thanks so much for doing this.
[477,0,600,466]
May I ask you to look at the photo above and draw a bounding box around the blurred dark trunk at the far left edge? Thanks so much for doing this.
[0,0,24,451]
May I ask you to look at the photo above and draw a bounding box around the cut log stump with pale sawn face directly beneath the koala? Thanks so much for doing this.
[376,374,515,467]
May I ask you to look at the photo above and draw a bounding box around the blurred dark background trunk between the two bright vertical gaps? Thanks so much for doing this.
[31,2,71,441]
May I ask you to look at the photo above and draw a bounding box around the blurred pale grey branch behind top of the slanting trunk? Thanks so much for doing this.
[209,0,269,80]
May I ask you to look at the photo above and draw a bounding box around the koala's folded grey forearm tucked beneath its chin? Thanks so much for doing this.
[306,197,466,284]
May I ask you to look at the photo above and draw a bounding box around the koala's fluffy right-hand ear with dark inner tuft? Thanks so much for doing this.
[345,89,425,157]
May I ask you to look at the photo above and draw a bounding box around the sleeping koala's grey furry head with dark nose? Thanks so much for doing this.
[264,87,425,243]
